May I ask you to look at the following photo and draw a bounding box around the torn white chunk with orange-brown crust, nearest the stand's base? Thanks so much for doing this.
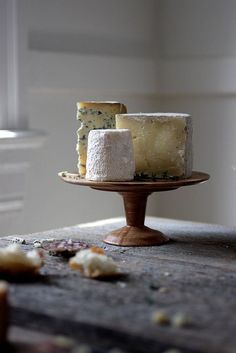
[69,248,118,278]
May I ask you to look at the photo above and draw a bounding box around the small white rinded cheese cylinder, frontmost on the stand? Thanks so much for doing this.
[86,129,135,181]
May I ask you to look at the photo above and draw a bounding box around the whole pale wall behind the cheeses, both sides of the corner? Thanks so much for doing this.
[4,0,236,233]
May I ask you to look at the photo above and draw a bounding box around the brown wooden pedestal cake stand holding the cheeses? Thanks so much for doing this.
[58,172,210,246]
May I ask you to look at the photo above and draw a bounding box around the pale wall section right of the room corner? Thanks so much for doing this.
[155,0,236,225]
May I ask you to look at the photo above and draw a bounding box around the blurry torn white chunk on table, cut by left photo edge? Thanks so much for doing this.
[0,244,43,275]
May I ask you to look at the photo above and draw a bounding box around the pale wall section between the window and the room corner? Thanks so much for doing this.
[18,0,161,233]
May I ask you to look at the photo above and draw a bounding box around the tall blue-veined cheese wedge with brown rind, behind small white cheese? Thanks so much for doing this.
[76,101,127,177]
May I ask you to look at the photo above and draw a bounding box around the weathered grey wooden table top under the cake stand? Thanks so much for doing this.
[0,217,236,353]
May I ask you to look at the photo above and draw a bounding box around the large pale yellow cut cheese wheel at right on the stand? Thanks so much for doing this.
[116,113,193,178]
